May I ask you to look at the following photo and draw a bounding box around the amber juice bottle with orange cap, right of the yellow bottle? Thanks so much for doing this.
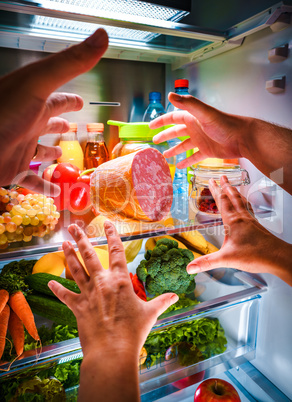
[84,123,109,169]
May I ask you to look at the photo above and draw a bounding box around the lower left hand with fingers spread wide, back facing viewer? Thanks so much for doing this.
[49,222,178,358]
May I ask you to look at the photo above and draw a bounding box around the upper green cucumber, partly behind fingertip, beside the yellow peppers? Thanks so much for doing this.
[24,272,80,298]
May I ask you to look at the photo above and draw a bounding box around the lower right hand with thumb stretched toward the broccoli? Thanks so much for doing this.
[187,176,292,285]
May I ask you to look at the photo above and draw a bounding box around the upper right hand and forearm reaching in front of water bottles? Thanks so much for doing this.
[150,93,292,194]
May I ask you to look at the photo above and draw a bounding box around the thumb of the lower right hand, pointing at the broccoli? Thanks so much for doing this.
[187,249,228,274]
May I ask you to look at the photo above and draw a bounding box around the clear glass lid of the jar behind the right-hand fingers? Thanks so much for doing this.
[194,163,250,186]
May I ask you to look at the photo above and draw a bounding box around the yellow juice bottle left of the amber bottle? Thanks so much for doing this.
[58,123,84,170]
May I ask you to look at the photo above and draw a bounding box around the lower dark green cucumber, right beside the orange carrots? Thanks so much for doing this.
[26,294,77,328]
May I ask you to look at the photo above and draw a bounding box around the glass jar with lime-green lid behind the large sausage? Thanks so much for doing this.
[107,120,175,180]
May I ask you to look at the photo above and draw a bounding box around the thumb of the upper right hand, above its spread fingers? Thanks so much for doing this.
[168,92,220,124]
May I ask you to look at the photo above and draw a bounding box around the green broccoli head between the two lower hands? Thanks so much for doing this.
[136,238,196,295]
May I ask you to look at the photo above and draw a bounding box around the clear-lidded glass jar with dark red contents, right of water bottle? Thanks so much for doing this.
[190,163,250,216]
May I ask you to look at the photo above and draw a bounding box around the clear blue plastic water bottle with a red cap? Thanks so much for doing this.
[166,79,190,220]
